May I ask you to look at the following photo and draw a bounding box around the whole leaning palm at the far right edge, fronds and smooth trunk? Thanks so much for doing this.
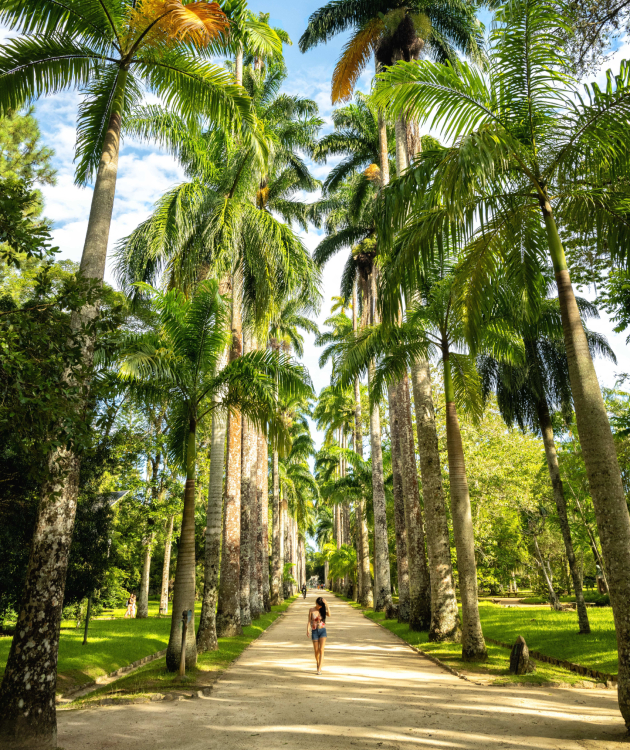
[376,0,630,712]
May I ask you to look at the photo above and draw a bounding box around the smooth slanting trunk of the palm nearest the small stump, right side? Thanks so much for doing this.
[443,351,488,661]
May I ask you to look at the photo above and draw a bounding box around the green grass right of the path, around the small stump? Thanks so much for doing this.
[346,599,617,685]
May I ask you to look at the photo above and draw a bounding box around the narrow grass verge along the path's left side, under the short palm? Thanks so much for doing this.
[70,596,297,708]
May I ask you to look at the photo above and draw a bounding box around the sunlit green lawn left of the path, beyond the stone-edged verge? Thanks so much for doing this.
[0,600,296,694]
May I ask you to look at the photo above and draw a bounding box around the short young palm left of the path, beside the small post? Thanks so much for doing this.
[120,280,309,671]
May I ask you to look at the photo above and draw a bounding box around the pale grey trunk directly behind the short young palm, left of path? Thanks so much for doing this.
[197,410,227,653]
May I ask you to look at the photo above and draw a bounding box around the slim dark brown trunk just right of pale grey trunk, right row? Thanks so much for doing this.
[388,383,410,622]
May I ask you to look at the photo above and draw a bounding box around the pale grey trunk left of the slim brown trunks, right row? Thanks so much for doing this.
[368,268,392,612]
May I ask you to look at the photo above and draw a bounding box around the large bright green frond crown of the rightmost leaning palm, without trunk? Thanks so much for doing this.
[374,0,630,338]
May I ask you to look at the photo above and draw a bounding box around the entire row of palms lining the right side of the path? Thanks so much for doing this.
[300,0,630,722]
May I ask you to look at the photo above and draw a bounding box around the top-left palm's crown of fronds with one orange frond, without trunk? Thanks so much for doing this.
[0,0,265,184]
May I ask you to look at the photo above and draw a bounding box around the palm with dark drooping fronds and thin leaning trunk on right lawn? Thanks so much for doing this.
[478,275,616,633]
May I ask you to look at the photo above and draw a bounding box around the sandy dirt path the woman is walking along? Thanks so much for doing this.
[59,593,630,750]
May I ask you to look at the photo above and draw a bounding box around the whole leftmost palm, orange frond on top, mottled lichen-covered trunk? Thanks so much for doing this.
[0,0,255,746]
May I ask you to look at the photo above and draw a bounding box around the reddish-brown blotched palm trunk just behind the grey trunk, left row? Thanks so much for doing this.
[217,274,243,637]
